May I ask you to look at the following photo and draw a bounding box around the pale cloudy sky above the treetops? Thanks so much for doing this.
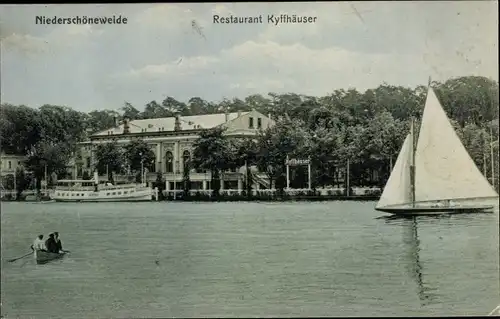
[0,1,498,112]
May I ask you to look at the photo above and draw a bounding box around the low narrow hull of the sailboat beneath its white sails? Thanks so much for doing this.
[375,205,493,216]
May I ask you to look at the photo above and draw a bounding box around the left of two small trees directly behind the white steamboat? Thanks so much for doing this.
[95,142,125,183]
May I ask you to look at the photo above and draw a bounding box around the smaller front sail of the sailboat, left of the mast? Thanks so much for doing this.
[377,134,412,208]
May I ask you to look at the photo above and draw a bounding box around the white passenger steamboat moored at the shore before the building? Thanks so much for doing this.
[50,173,154,202]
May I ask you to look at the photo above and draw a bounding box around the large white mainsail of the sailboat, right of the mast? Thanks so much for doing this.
[415,89,498,202]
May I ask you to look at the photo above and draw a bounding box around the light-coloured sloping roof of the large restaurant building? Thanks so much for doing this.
[92,112,250,136]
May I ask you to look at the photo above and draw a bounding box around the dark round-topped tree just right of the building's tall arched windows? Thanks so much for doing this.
[192,127,230,196]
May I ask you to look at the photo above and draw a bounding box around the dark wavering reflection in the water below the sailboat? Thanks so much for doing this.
[384,216,440,306]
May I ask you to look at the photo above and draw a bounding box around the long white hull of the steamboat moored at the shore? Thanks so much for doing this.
[51,187,153,203]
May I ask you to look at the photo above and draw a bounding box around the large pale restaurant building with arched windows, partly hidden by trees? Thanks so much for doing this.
[76,110,275,190]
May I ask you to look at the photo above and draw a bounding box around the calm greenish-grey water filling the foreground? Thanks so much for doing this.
[1,202,500,318]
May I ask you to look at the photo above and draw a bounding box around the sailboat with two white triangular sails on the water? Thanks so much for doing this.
[375,86,498,215]
